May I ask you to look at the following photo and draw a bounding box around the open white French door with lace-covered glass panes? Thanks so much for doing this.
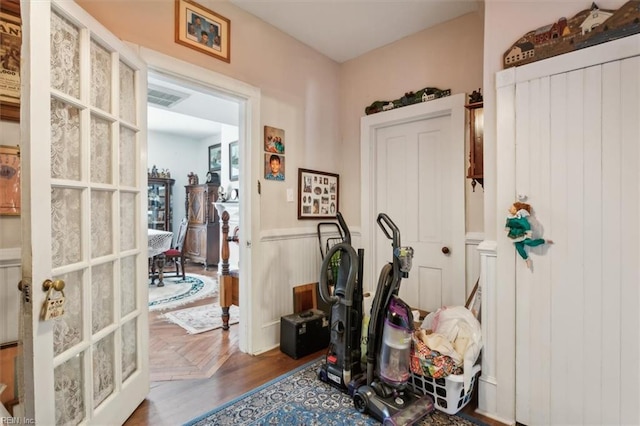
[20,0,149,425]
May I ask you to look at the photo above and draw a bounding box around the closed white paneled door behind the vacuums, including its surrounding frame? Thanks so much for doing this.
[362,94,465,312]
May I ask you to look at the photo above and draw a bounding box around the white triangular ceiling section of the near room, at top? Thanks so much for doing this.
[230,0,483,63]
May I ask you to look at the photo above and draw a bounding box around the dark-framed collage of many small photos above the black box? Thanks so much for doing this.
[298,169,340,219]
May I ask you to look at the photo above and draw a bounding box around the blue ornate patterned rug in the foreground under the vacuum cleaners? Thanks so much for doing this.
[185,358,487,426]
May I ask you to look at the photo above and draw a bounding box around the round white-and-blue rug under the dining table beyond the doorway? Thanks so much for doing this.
[149,274,218,311]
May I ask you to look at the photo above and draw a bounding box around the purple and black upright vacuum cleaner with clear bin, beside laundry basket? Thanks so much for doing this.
[353,213,434,425]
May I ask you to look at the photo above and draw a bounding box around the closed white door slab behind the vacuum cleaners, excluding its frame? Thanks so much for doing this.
[376,116,464,312]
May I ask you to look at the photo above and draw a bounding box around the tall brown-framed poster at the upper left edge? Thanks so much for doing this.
[0,0,22,121]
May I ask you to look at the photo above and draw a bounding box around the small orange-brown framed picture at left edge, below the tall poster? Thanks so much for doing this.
[0,145,21,216]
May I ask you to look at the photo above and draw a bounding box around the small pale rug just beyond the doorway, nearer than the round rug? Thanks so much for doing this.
[162,303,240,334]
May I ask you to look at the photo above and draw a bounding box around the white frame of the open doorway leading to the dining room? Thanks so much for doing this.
[138,47,262,354]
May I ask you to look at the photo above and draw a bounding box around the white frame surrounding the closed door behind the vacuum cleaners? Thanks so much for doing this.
[360,93,466,291]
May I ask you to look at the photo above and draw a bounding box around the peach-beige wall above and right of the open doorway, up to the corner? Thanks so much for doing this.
[78,0,344,230]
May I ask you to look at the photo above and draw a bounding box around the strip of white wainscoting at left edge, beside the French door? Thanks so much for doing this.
[0,248,21,344]
